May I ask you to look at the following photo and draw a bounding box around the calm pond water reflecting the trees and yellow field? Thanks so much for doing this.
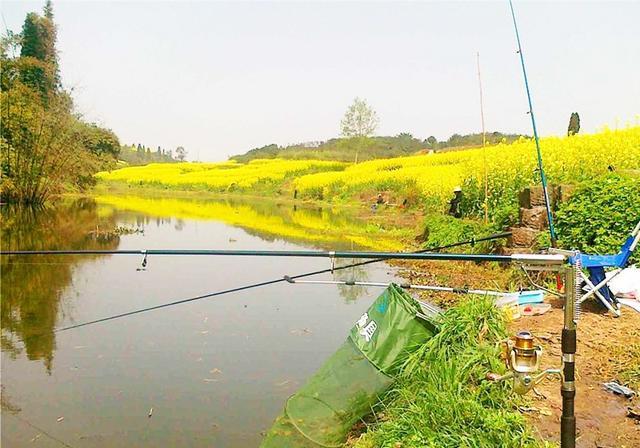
[1,196,397,447]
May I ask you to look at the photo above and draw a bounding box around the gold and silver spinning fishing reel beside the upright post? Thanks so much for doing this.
[487,331,562,395]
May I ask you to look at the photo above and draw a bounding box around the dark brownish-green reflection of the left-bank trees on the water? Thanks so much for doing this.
[0,199,119,373]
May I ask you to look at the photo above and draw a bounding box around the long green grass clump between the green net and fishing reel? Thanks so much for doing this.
[356,297,543,448]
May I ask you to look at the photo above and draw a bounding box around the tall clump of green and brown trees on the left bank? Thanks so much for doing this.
[0,1,120,204]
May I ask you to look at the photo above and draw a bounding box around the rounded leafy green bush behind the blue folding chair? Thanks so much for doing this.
[556,174,640,260]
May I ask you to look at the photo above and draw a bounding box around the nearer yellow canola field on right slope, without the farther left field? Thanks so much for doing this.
[294,127,640,206]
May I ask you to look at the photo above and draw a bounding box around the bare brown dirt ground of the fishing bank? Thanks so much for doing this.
[397,262,640,448]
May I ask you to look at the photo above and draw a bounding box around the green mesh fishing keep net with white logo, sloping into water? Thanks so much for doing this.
[260,284,436,448]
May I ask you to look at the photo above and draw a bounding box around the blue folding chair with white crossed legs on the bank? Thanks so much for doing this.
[569,221,640,317]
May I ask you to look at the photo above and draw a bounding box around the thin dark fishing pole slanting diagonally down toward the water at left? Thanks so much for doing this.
[54,232,511,332]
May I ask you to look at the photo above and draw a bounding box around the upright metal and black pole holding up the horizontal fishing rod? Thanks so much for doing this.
[560,265,579,448]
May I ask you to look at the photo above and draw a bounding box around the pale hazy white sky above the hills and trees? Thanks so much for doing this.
[1,0,640,160]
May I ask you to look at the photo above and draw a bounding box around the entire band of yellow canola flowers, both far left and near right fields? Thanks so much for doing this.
[97,126,640,213]
